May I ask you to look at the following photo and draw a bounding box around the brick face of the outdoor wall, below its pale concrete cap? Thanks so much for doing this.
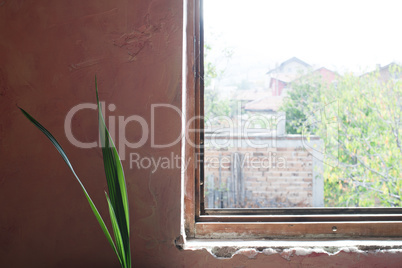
[205,137,313,207]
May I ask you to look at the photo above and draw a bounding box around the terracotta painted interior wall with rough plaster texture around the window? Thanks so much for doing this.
[0,0,402,267]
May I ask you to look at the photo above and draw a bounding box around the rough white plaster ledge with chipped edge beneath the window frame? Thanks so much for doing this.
[182,239,402,260]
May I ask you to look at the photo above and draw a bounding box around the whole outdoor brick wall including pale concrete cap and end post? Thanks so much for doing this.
[204,135,323,208]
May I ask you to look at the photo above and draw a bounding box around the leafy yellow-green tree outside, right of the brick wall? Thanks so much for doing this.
[282,66,402,207]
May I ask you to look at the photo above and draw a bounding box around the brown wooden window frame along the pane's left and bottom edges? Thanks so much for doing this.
[182,0,402,240]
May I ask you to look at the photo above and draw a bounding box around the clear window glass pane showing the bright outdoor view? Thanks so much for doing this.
[204,0,402,208]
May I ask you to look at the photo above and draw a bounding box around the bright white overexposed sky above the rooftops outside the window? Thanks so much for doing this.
[204,0,402,71]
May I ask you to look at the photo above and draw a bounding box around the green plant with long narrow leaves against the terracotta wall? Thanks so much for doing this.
[20,77,131,268]
